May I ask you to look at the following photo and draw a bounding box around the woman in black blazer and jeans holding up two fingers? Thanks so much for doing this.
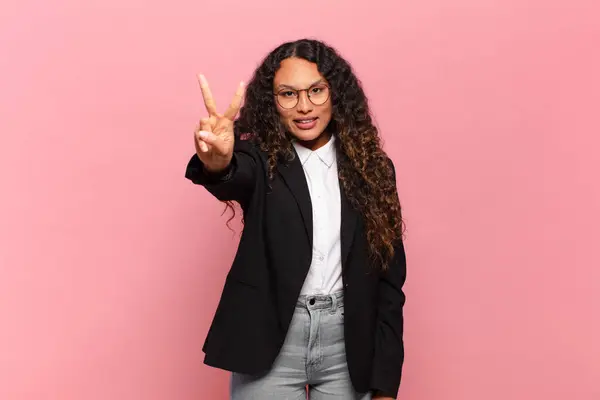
[186,40,406,400]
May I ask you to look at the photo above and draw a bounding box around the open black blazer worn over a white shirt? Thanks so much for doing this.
[185,138,406,398]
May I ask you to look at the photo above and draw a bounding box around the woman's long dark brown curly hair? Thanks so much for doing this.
[235,39,404,270]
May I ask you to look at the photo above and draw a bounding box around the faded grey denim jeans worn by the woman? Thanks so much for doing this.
[231,291,371,400]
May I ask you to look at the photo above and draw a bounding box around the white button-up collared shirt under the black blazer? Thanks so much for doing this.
[294,136,343,294]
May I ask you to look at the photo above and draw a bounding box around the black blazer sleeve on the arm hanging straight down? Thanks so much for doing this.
[371,159,406,398]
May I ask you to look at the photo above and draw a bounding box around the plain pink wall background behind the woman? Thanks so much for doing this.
[0,0,600,400]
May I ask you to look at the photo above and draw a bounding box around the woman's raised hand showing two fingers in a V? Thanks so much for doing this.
[194,75,245,172]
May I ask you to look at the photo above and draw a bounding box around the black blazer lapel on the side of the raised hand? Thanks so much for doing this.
[277,154,313,249]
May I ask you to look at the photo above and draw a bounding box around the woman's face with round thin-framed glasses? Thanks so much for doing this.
[273,57,332,150]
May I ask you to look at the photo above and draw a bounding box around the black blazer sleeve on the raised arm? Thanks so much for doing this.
[185,140,259,204]
